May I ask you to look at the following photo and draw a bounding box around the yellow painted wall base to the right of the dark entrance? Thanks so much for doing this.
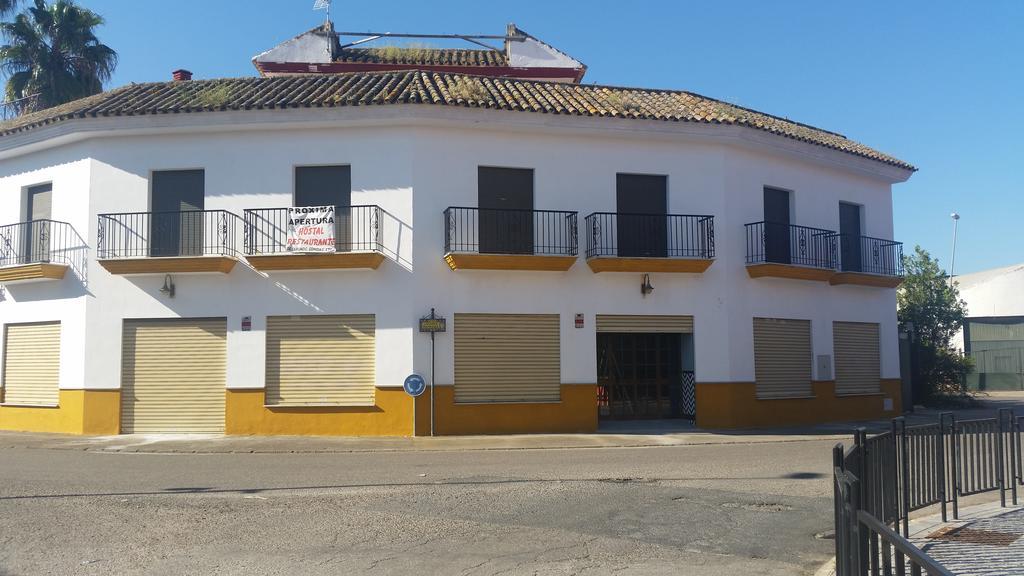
[697,379,902,428]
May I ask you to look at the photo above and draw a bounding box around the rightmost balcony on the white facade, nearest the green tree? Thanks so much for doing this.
[828,234,903,288]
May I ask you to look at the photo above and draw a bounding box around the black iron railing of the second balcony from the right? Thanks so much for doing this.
[745,221,838,269]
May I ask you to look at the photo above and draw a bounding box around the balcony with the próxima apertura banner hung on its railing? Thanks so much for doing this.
[244,206,385,272]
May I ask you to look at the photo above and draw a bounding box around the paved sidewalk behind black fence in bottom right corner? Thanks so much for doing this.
[910,495,1024,576]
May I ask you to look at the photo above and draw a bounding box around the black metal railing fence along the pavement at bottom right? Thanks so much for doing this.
[833,409,1024,576]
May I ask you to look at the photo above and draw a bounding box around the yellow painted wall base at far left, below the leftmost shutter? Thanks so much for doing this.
[0,390,121,436]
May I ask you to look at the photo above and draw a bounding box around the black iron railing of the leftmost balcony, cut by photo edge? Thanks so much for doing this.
[0,220,89,274]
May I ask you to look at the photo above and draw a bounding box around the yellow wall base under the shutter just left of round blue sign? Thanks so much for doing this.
[224,388,413,436]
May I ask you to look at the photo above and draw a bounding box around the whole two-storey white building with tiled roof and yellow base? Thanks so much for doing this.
[0,52,914,436]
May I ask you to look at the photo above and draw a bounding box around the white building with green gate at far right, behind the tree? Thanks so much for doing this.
[955,264,1024,390]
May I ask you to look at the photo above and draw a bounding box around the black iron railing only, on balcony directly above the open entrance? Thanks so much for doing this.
[585,212,715,258]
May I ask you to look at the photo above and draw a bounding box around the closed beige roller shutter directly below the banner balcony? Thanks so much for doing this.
[266,314,376,406]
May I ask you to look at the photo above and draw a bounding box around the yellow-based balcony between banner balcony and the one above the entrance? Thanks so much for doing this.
[444,207,579,272]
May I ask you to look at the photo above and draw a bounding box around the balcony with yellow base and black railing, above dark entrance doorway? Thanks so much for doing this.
[585,212,715,274]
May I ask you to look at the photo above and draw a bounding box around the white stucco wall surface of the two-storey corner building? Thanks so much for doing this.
[0,106,899,388]
